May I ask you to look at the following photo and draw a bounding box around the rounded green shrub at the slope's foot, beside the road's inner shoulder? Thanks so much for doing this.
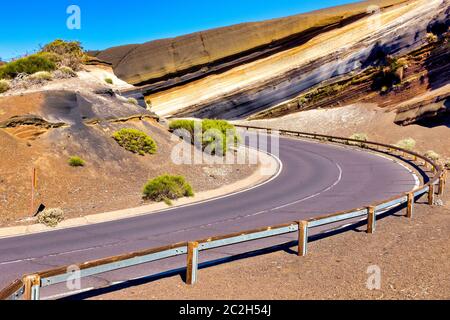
[143,175,194,204]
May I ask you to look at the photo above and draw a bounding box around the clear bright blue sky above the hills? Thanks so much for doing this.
[0,0,357,60]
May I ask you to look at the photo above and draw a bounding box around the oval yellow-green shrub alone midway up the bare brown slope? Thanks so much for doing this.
[113,129,157,156]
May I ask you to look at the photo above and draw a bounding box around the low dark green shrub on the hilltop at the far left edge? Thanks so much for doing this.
[0,52,58,79]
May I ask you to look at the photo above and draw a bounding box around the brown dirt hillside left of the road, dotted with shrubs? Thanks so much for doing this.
[0,68,258,227]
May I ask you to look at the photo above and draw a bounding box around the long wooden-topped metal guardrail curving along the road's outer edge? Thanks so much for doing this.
[0,125,446,300]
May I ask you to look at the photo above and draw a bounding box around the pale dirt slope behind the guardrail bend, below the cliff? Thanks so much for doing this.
[236,103,450,159]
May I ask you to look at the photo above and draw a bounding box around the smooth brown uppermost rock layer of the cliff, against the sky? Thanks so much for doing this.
[97,0,406,85]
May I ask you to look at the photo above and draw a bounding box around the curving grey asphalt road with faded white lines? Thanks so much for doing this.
[0,137,416,297]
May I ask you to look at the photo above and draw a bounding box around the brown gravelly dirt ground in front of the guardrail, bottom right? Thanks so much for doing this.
[94,175,450,300]
